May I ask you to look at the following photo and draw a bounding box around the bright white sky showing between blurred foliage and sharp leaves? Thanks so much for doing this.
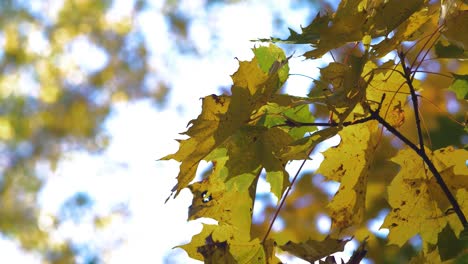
[0,0,383,264]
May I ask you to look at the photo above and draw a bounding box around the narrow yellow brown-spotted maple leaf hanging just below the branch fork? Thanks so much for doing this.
[317,122,377,231]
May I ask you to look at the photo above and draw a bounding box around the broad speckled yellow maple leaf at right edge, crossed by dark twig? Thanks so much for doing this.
[382,147,468,246]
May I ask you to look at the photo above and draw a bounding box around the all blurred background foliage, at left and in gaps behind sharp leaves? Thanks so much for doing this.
[0,0,468,263]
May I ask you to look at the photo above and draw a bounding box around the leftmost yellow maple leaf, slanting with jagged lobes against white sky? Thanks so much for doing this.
[162,44,287,196]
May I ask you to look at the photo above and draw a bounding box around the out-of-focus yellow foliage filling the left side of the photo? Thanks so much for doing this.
[0,0,194,263]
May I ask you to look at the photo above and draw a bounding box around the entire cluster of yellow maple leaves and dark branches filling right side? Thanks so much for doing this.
[163,0,468,263]
